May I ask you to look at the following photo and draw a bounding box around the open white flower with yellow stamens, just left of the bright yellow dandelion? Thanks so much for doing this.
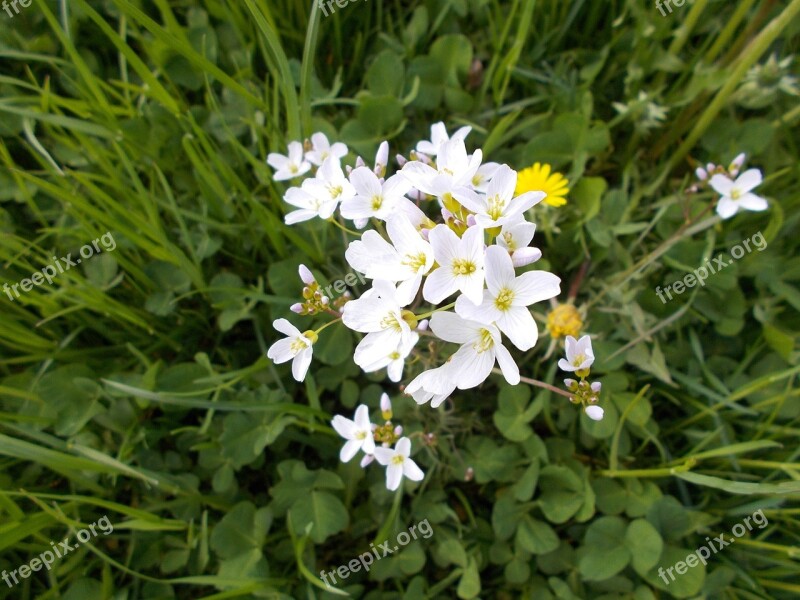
[453,165,547,229]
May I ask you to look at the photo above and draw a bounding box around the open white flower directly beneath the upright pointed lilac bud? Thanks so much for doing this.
[341,167,411,221]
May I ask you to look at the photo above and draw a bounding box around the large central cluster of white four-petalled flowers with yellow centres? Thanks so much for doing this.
[268,123,584,489]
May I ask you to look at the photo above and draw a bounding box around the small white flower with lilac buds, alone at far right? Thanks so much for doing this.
[688,153,768,219]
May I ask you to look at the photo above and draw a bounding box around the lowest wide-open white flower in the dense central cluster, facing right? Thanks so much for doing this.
[431,312,519,390]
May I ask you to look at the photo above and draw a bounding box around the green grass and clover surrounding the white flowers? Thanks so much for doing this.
[0,0,800,600]
